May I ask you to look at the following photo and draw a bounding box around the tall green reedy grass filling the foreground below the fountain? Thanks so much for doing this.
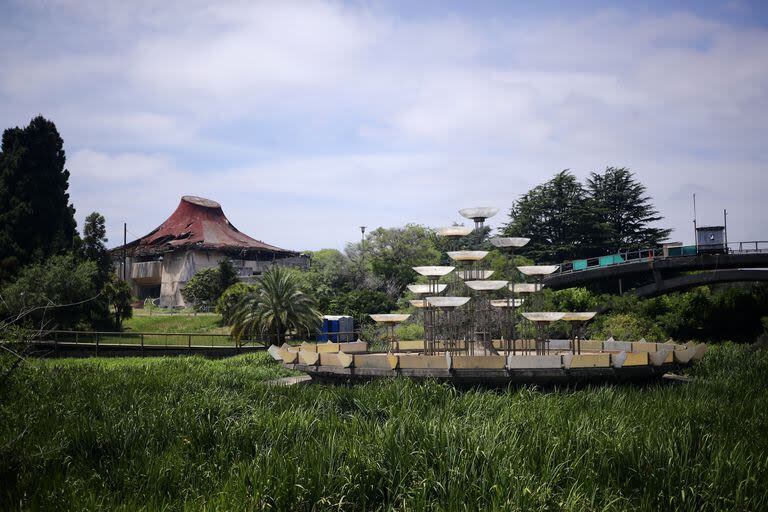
[0,346,768,511]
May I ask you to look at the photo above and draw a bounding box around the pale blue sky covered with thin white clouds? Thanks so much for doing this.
[0,0,768,250]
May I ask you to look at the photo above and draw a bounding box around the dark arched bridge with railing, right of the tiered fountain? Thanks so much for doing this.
[543,250,768,295]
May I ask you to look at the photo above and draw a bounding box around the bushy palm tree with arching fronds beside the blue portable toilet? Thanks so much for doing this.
[232,265,321,345]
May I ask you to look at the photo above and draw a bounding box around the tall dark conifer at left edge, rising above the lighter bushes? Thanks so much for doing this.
[0,116,76,280]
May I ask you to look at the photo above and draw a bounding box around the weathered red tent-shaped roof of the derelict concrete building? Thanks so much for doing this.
[115,196,297,256]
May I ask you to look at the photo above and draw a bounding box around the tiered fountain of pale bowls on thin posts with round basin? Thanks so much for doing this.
[269,207,706,384]
